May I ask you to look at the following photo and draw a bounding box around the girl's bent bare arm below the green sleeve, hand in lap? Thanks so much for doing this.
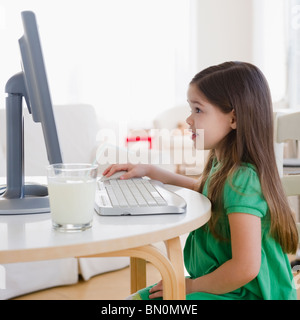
[149,213,261,298]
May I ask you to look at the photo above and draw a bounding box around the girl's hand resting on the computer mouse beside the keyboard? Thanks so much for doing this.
[102,163,150,180]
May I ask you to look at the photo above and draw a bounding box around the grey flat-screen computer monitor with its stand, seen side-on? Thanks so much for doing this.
[0,11,63,215]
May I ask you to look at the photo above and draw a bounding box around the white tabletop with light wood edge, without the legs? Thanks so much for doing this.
[0,185,211,263]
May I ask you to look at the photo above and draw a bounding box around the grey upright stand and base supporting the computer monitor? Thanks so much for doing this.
[0,72,50,215]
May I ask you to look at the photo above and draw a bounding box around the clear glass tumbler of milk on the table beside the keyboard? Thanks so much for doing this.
[47,163,98,231]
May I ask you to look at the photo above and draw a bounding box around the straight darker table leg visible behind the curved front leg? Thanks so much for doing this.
[130,257,146,293]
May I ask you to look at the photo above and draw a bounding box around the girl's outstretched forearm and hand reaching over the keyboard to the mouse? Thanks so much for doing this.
[103,163,197,190]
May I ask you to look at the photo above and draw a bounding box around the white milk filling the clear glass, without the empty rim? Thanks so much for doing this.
[48,178,96,225]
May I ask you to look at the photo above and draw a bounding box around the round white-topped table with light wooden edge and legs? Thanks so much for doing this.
[0,185,211,299]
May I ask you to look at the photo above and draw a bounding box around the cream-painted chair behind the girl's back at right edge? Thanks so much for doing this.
[274,112,300,266]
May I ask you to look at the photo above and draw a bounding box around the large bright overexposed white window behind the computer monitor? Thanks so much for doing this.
[0,0,191,127]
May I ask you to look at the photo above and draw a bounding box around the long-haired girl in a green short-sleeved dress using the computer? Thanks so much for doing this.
[103,62,298,299]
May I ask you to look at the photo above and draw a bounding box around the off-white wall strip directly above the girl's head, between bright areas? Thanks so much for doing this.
[194,0,253,71]
